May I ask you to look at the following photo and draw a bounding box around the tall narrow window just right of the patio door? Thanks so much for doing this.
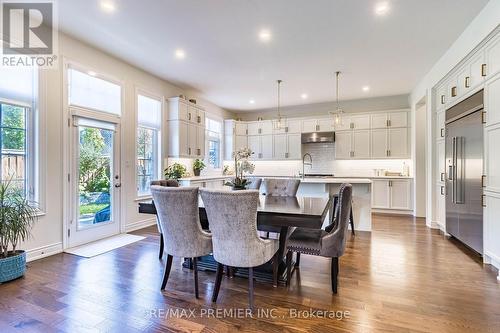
[137,95,161,196]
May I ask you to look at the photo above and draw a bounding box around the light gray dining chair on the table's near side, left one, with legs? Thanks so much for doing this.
[151,186,212,298]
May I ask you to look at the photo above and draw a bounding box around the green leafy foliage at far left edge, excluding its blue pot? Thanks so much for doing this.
[0,180,37,258]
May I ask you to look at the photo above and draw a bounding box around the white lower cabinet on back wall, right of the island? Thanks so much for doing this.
[372,179,412,210]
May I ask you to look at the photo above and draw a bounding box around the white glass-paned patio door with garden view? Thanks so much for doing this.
[68,117,121,247]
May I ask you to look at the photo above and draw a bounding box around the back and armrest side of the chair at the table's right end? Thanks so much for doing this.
[321,183,352,257]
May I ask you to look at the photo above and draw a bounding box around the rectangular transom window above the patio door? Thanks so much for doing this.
[68,68,121,115]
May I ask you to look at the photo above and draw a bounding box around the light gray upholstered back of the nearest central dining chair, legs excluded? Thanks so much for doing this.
[200,189,264,267]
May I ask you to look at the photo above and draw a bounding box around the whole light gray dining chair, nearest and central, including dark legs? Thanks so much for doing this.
[200,189,279,309]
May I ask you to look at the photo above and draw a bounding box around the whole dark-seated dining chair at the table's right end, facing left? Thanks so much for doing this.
[286,184,352,294]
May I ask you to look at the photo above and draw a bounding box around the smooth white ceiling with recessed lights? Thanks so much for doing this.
[58,0,488,111]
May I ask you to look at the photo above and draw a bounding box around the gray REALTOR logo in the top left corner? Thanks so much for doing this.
[0,0,57,67]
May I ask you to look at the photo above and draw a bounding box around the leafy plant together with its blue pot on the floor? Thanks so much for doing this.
[0,180,36,283]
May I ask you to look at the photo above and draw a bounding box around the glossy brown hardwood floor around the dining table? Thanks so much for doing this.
[0,215,500,333]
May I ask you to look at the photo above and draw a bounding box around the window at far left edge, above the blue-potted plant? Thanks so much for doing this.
[0,67,39,201]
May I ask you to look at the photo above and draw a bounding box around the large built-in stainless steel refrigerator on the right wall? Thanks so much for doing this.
[445,90,483,254]
